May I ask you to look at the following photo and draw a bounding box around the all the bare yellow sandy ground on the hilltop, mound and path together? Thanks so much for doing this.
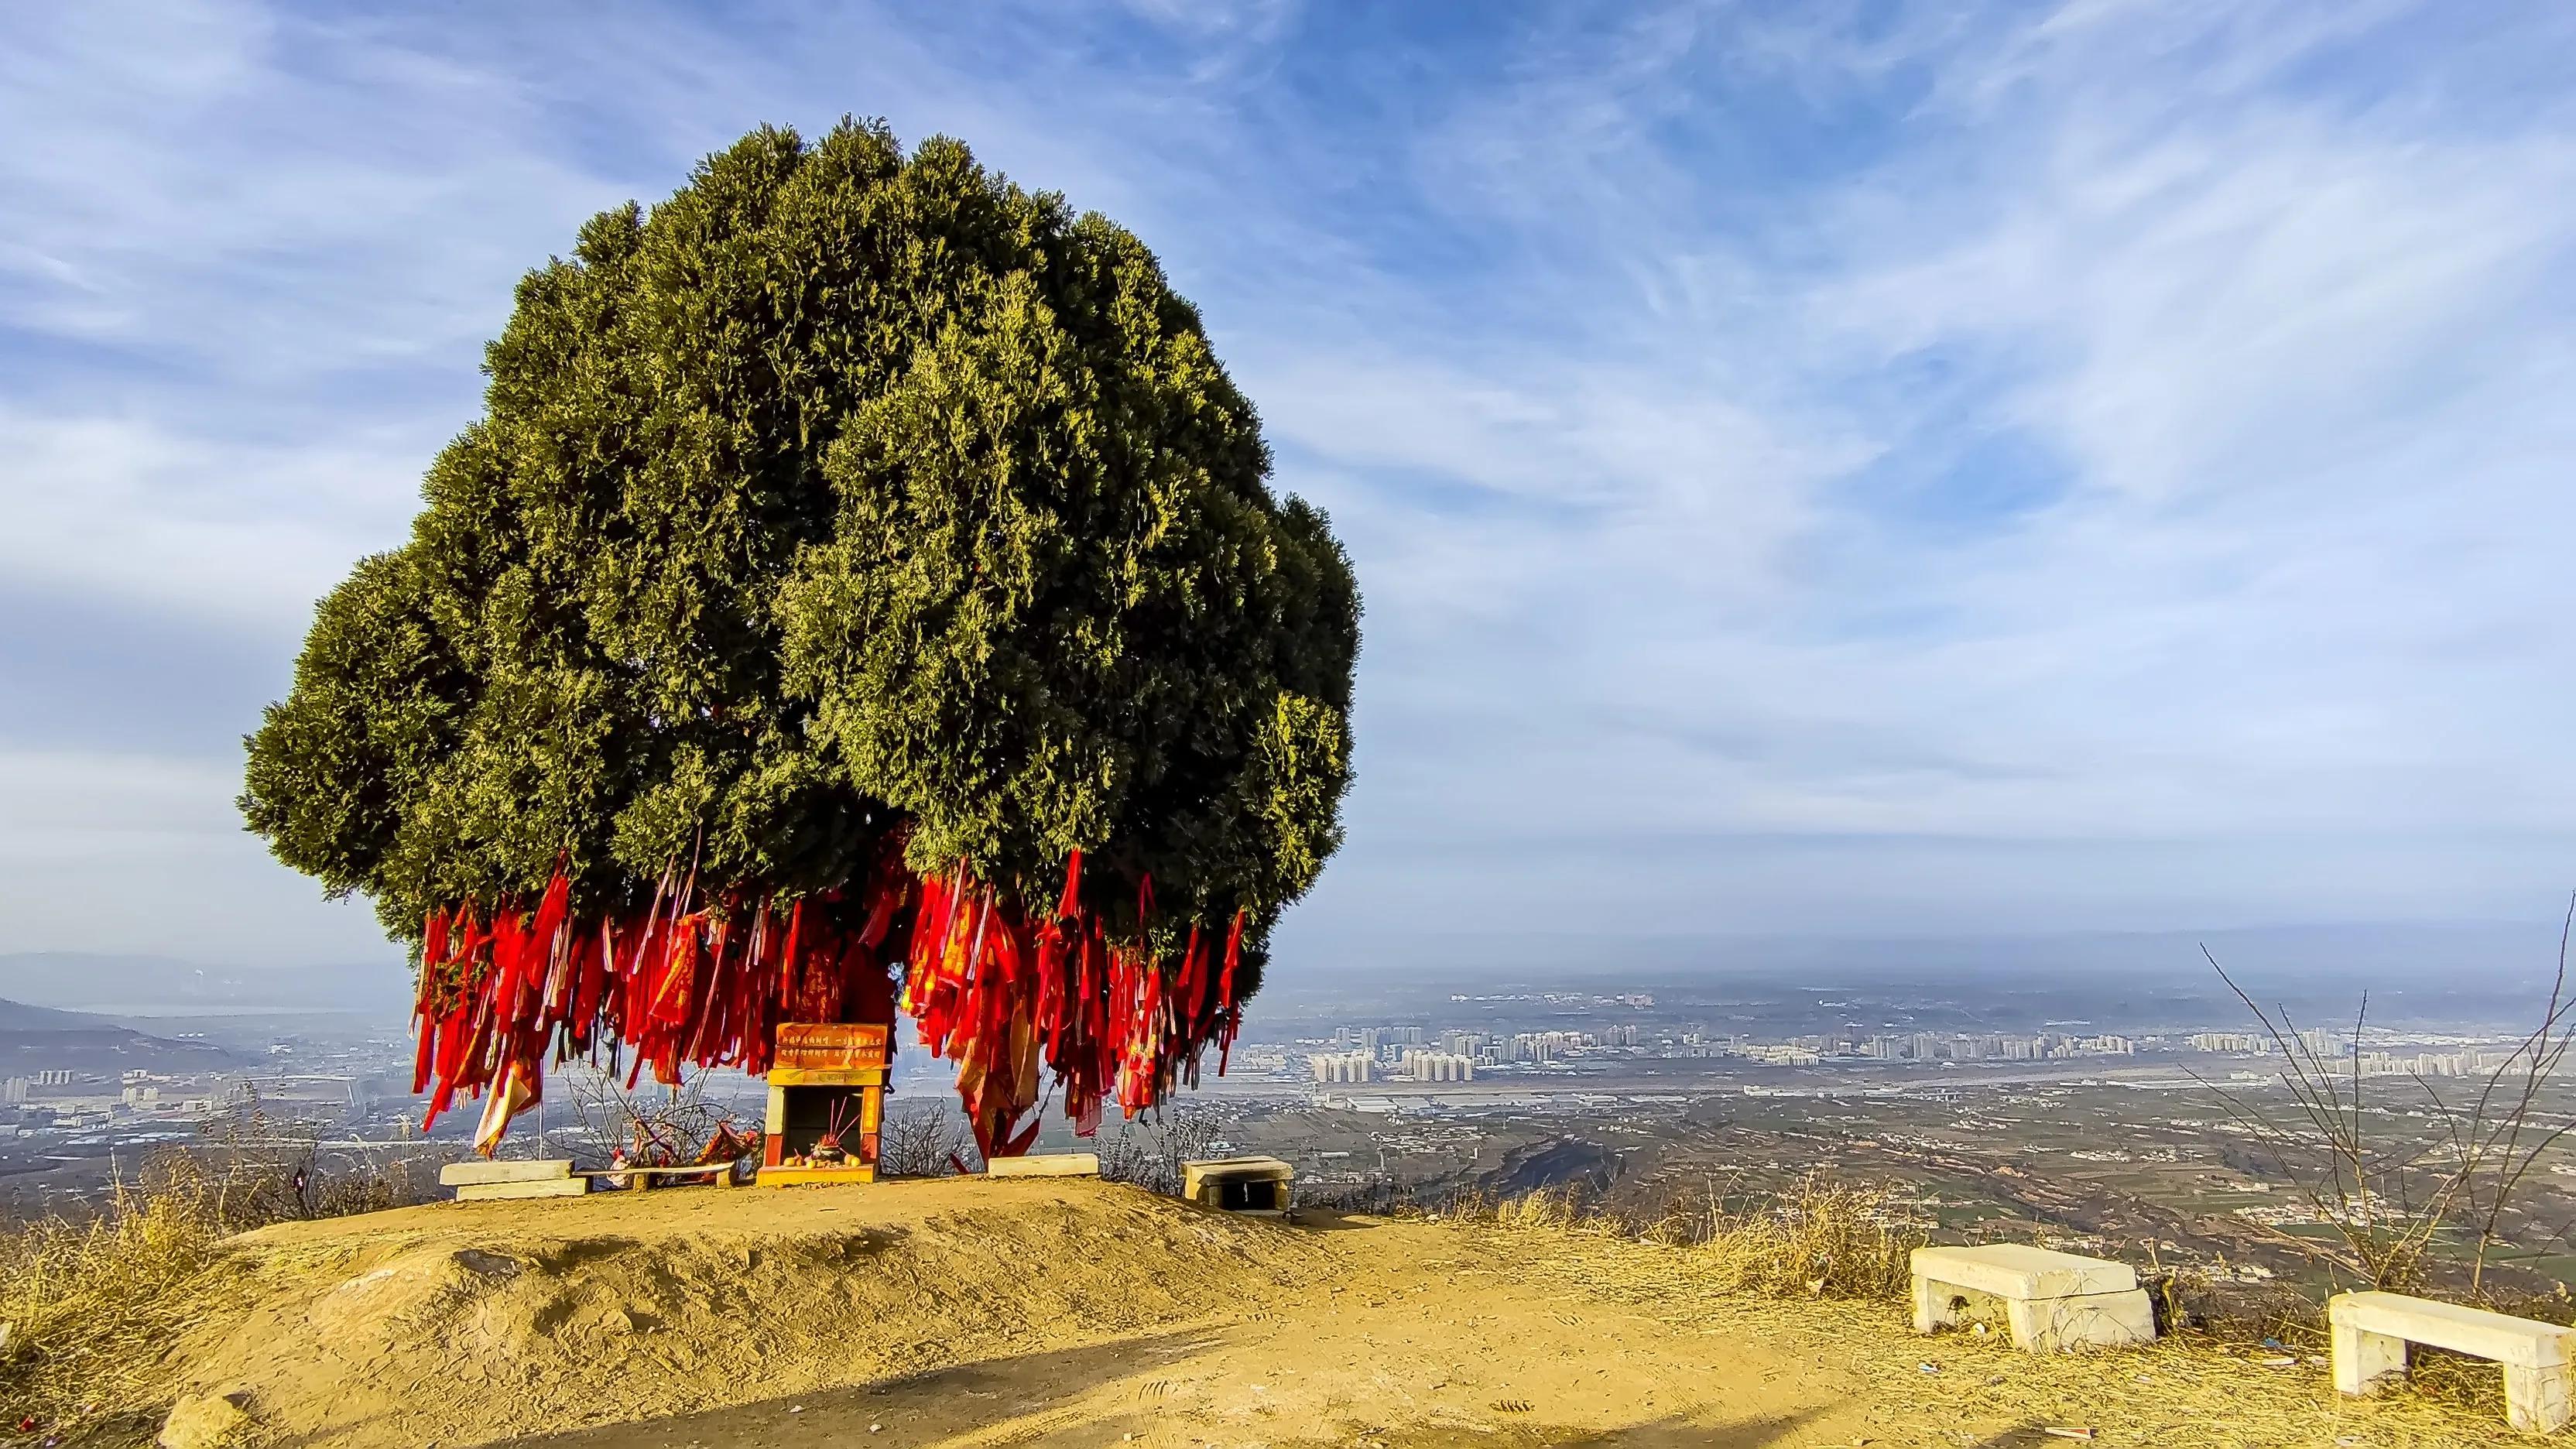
[150,1178,2501,1449]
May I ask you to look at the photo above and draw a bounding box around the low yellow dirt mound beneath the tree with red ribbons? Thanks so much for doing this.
[183,1181,1314,1444]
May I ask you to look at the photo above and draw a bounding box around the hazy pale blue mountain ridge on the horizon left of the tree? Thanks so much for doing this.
[0,951,412,1016]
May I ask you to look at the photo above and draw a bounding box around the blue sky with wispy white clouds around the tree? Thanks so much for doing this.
[0,0,2576,961]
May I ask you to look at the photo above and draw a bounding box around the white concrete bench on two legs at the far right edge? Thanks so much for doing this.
[2326,1292,2576,1434]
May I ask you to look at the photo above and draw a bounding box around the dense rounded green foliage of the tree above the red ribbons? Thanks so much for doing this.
[242,122,1360,990]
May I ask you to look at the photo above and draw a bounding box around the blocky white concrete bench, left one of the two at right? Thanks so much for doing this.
[1911,1243,2156,1354]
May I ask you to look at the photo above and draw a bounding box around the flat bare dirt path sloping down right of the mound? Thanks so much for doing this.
[497,1220,1886,1449]
